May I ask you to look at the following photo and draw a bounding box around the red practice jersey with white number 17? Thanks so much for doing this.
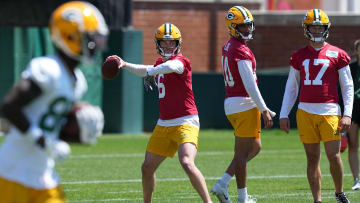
[290,43,350,103]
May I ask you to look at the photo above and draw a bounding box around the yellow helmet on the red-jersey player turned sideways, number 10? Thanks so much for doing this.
[225,6,255,40]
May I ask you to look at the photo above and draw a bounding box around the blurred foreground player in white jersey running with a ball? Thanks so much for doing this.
[0,2,108,203]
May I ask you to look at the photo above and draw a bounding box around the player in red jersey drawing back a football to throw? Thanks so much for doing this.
[109,23,211,203]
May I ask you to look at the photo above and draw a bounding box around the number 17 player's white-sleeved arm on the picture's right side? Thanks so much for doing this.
[338,66,354,132]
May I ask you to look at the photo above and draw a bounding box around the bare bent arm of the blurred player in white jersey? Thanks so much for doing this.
[1,79,42,133]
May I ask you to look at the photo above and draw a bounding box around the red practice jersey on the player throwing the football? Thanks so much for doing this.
[154,53,198,120]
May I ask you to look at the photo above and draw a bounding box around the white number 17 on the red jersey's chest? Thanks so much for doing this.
[302,59,330,85]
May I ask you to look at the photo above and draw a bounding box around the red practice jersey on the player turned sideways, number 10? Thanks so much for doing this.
[221,37,257,98]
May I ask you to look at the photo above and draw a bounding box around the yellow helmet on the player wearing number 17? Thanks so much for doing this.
[303,9,331,42]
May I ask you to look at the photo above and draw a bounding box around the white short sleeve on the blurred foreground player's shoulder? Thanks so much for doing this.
[22,58,58,91]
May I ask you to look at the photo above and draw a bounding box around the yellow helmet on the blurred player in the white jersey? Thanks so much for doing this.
[49,1,109,62]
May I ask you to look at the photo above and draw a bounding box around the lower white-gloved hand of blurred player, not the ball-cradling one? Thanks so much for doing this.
[36,135,71,162]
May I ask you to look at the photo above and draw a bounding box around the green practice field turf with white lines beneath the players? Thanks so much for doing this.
[0,130,360,203]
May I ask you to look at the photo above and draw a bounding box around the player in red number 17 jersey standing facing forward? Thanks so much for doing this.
[280,9,354,203]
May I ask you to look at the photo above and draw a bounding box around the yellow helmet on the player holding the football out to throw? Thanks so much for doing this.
[155,23,181,58]
